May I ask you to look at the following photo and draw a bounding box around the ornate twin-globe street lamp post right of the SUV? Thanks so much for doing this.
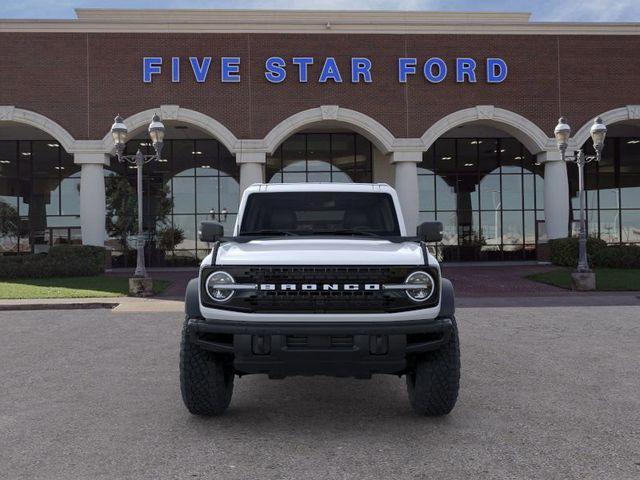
[554,117,607,287]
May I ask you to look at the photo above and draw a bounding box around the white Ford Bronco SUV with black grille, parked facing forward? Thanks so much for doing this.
[180,183,460,416]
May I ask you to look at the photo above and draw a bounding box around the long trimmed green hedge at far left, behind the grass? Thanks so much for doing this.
[0,245,106,278]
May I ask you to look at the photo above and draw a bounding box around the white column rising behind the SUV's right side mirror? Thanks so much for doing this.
[391,152,422,235]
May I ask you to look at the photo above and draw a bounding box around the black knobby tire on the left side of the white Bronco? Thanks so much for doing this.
[180,318,233,416]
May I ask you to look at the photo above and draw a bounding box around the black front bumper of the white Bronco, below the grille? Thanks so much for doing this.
[189,318,452,378]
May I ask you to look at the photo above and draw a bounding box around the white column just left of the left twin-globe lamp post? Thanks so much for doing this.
[74,153,109,247]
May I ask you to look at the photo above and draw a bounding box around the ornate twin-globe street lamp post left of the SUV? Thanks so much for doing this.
[111,114,165,278]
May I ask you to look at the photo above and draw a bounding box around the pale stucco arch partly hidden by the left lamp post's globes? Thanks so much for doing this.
[102,105,239,155]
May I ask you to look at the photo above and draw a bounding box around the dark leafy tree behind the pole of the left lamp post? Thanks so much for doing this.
[105,175,173,251]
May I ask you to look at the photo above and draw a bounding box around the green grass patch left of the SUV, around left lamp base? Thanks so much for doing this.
[0,275,170,299]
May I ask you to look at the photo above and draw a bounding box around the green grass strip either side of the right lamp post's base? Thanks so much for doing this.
[526,268,640,292]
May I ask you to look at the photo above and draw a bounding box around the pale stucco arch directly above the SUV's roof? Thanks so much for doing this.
[263,105,395,154]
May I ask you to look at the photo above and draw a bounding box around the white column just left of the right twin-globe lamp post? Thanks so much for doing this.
[537,152,569,239]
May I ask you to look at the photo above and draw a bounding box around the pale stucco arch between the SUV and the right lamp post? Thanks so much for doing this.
[421,105,555,154]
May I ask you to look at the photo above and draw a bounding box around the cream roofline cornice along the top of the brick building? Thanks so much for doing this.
[0,9,640,35]
